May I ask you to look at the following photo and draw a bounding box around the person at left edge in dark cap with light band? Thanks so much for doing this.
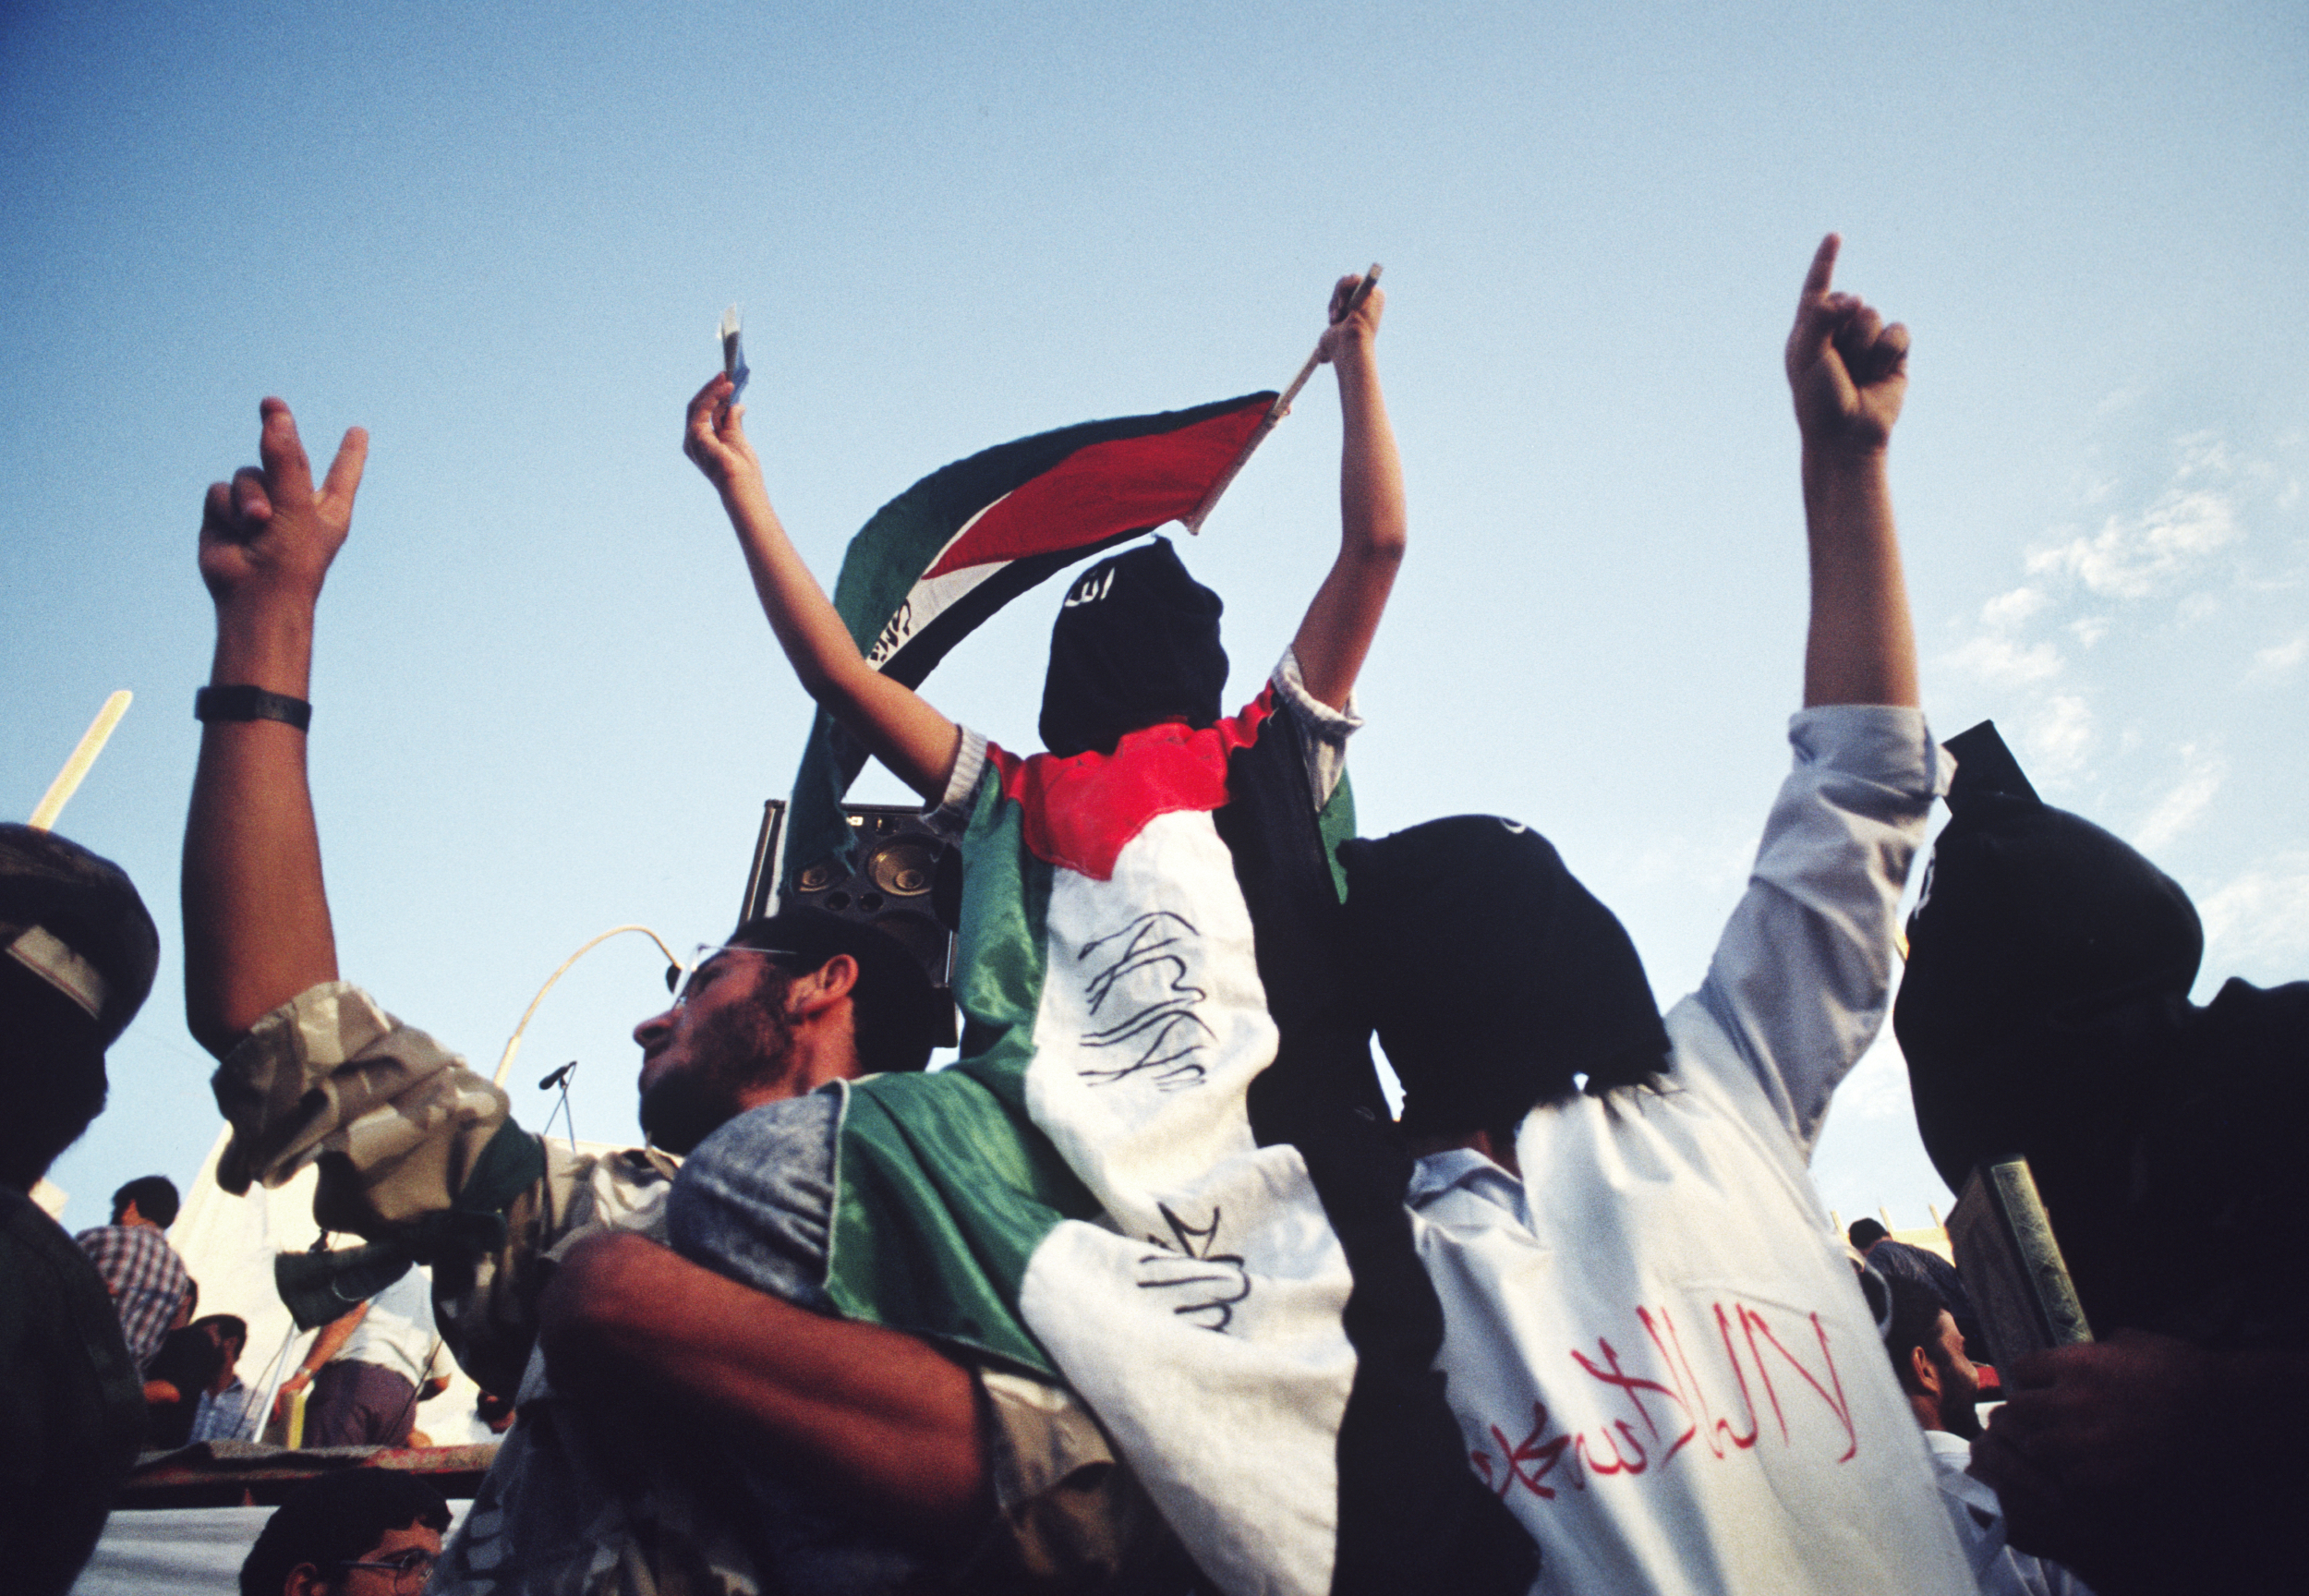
[0,825,160,1596]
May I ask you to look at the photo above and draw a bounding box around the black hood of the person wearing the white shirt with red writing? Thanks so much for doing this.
[1339,816,1667,1131]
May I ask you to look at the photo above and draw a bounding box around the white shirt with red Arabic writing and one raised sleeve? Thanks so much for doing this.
[1408,707,1975,1596]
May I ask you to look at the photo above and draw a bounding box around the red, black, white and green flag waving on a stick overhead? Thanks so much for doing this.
[785,391,1275,877]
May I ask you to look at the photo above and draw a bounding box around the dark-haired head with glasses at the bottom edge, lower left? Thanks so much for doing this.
[240,1469,448,1596]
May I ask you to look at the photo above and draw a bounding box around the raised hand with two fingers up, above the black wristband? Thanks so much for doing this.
[201,400,369,610]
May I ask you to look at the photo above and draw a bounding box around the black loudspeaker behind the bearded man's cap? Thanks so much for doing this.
[739,799,963,1046]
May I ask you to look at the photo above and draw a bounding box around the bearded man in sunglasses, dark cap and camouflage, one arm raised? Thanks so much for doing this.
[183,400,1164,1596]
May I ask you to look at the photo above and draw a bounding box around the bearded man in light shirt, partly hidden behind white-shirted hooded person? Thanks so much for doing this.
[1864,1275,2092,1596]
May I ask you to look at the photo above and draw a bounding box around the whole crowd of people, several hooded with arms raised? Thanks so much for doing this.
[0,236,2309,1596]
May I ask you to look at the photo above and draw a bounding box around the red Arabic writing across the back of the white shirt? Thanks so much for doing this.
[1469,1302,1861,1501]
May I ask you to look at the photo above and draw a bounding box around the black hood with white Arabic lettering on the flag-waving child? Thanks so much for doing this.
[1042,538,1227,757]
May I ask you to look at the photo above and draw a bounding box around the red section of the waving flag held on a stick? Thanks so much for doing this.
[922,397,1270,582]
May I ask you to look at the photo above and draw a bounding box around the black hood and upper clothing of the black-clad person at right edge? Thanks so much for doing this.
[1893,723,2309,1347]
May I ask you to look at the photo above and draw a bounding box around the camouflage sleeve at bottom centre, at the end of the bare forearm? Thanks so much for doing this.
[961,1367,1194,1596]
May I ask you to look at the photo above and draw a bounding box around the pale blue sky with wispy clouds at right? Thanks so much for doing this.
[0,0,2309,1224]
